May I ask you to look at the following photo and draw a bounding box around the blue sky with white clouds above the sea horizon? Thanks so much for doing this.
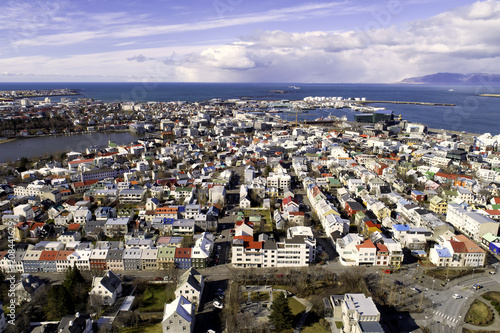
[0,0,500,83]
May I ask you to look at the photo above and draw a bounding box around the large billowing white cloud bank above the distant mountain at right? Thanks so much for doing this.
[168,1,500,82]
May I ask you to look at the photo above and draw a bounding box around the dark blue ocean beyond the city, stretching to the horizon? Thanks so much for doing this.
[0,82,500,135]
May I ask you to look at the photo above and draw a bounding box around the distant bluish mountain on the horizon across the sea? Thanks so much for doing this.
[398,73,500,85]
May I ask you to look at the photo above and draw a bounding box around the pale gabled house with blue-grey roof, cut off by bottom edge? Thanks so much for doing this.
[161,296,195,333]
